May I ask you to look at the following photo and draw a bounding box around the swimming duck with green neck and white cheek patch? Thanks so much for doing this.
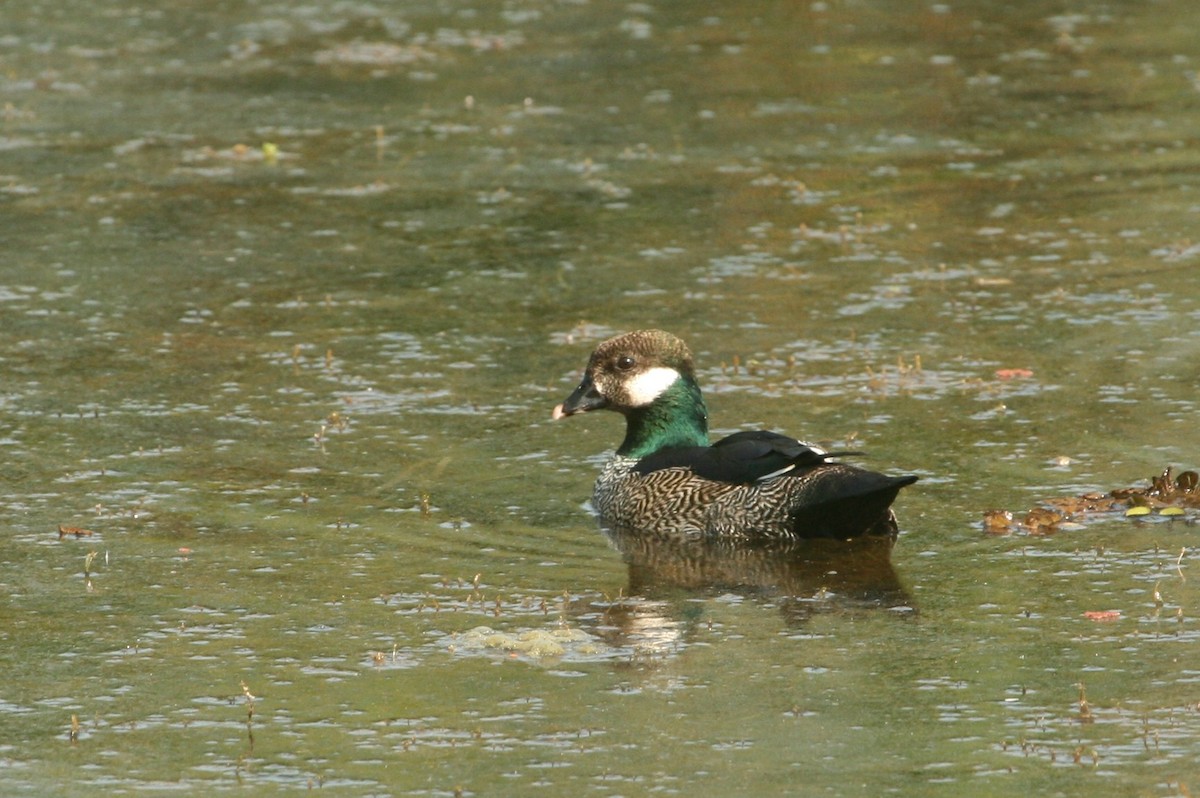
[551,330,918,541]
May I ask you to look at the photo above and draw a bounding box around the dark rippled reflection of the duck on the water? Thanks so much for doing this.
[595,530,913,653]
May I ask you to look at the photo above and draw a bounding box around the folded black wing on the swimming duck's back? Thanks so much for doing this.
[634,430,856,484]
